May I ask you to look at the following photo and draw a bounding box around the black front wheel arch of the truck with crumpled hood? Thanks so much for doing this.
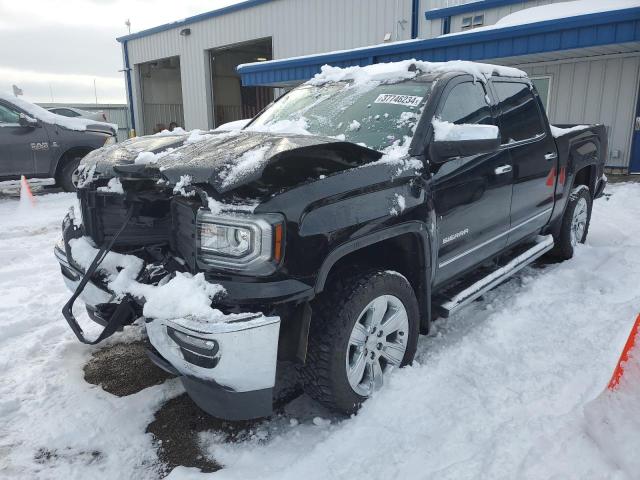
[315,221,431,333]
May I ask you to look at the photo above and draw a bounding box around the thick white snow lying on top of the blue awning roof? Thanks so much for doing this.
[441,0,638,37]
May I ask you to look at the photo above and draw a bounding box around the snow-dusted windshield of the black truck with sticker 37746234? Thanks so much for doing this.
[248,80,432,151]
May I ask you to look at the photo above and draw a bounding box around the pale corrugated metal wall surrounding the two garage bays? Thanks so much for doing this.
[127,0,412,131]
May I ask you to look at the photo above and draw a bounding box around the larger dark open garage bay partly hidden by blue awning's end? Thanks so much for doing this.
[211,38,273,127]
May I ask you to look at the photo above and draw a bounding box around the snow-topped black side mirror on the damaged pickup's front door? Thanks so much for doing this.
[430,118,501,163]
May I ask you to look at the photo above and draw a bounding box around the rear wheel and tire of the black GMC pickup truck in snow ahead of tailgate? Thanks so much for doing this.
[553,185,593,260]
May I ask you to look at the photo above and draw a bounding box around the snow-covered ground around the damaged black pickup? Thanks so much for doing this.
[0,184,640,480]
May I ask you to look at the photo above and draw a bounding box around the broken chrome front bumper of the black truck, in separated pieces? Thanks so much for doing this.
[54,214,280,420]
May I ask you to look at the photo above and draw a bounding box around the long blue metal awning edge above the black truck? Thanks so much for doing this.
[238,7,640,86]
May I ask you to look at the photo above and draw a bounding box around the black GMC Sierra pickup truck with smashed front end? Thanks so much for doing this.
[55,62,607,419]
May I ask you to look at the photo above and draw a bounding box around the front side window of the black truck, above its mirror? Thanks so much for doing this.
[438,82,494,125]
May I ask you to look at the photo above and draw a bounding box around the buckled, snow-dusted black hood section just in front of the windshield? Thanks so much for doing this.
[147,130,382,193]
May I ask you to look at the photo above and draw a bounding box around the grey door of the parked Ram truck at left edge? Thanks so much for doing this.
[0,102,51,177]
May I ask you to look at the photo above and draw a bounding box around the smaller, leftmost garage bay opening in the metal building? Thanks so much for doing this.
[139,57,184,135]
